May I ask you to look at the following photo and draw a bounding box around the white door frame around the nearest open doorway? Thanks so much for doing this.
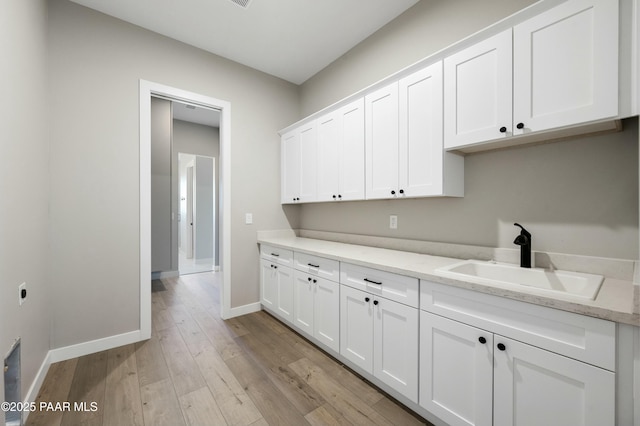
[140,79,231,340]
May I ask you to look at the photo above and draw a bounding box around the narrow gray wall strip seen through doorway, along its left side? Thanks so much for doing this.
[151,98,177,272]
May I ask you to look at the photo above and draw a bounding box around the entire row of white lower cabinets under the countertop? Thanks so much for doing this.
[260,245,626,426]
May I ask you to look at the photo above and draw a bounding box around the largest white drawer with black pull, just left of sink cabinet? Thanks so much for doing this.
[340,263,419,308]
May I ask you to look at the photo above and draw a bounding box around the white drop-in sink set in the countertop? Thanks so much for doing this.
[435,260,602,300]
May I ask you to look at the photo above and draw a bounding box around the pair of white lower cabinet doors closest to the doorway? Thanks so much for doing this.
[260,259,293,322]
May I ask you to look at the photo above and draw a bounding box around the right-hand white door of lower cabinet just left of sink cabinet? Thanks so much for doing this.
[376,296,419,403]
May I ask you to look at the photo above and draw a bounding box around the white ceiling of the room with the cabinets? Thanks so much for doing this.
[71,0,419,84]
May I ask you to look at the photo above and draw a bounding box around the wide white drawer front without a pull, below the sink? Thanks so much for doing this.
[420,280,616,371]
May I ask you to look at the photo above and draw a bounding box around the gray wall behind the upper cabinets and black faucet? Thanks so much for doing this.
[296,0,638,259]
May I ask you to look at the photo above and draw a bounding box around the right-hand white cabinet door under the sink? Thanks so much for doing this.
[493,335,615,426]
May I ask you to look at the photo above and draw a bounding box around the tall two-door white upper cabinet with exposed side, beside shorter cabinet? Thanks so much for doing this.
[365,61,464,199]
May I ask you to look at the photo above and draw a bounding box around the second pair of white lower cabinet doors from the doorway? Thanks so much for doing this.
[293,271,340,352]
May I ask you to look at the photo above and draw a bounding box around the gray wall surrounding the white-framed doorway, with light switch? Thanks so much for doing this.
[48,0,299,347]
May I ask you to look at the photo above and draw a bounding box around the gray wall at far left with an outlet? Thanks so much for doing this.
[0,0,52,412]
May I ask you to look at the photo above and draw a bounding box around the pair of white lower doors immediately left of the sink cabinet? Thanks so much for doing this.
[340,285,418,402]
